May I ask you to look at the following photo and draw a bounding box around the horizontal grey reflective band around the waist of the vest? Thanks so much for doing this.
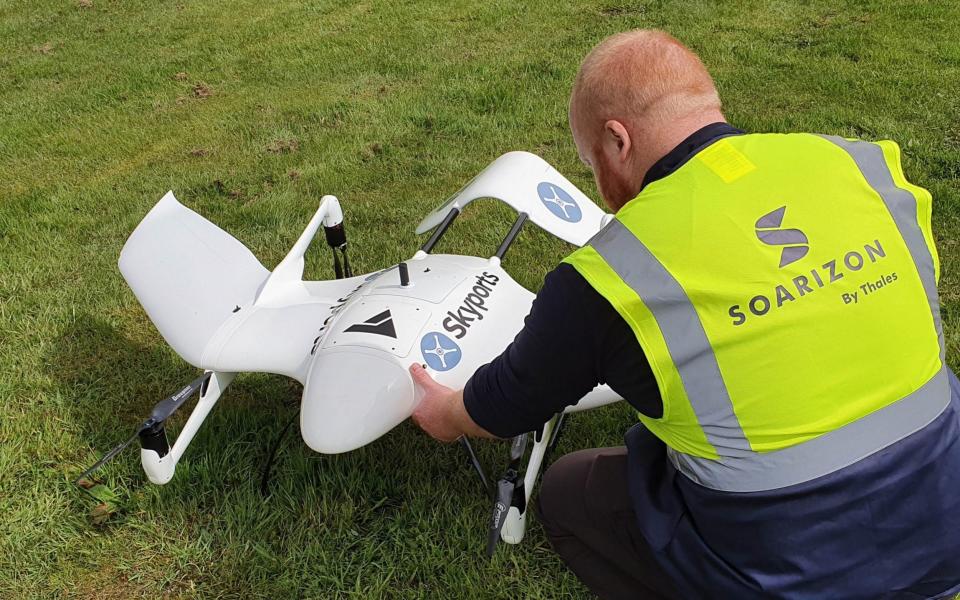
[667,368,950,492]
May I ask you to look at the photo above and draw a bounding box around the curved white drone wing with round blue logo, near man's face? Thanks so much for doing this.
[417,152,608,246]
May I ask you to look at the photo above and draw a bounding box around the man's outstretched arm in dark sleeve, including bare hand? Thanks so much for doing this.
[410,264,624,441]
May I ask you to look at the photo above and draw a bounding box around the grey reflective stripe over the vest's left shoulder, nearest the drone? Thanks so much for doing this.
[588,219,751,456]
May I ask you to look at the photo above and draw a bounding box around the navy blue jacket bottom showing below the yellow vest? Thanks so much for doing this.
[656,390,960,598]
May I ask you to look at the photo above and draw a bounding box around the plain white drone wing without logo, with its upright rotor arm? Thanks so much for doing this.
[120,192,362,381]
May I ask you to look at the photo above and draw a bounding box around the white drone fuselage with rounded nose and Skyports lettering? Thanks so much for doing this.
[300,252,534,453]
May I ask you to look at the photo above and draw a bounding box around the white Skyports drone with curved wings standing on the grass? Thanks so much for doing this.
[84,152,620,553]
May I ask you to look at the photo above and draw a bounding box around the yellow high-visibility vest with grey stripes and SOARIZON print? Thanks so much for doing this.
[566,134,949,492]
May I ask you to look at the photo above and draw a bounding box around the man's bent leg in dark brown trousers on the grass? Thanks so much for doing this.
[538,447,679,599]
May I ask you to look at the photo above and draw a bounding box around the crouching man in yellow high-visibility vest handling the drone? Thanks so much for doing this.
[411,30,960,598]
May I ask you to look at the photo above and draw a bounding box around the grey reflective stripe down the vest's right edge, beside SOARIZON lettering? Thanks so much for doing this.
[820,135,946,361]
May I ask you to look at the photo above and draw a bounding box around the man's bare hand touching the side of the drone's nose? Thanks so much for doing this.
[410,364,493,442]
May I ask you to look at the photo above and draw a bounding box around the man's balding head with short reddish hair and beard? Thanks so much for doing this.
[570,29,724,211]
